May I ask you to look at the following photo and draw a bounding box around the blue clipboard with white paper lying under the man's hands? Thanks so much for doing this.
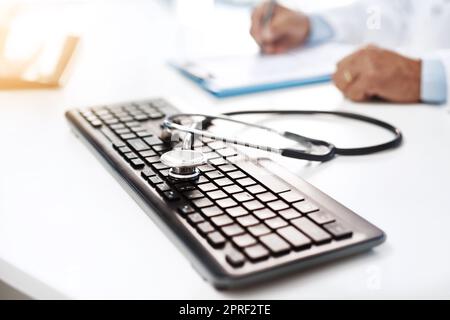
[170,43,353,98]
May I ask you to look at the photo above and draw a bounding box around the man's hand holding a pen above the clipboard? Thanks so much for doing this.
[250,2,310,54]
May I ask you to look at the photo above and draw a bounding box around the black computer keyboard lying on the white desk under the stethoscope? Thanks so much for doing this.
[66,99,385,289]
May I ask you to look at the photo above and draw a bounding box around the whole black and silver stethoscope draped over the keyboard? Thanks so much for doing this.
[161,110,402,180]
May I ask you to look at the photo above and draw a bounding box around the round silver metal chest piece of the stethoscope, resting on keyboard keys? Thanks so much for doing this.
[161,149,206,180]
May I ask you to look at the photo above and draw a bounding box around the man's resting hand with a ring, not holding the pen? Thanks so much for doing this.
[333,46,421,103]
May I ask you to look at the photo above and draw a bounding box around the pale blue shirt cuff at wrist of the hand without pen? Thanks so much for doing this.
[420,59,447,104]
